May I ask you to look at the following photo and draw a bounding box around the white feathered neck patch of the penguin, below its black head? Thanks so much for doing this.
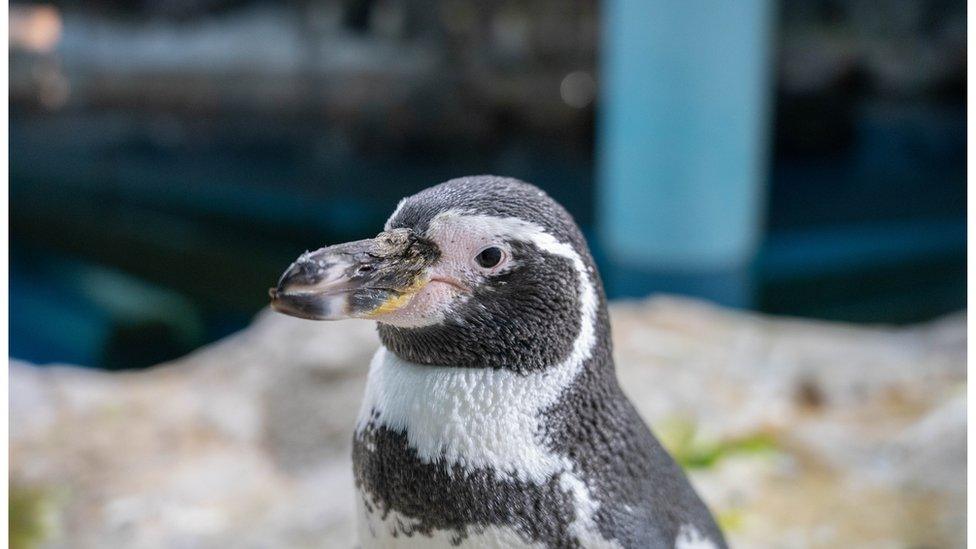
[356,308,614,484]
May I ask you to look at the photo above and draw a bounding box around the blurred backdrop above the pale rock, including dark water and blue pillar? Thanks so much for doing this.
[9,0,966,368]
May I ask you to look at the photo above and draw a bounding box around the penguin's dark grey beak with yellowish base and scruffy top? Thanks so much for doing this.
[268,229,439,320]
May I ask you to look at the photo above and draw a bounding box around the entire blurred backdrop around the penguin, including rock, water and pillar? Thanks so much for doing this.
[8,0,967,549]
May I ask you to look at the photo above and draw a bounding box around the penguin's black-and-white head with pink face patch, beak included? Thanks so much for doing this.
[271,176,606,372]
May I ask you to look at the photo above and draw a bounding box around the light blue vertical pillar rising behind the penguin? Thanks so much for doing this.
[598,0,773,306]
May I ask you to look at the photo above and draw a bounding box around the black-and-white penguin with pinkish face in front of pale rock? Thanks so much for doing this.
[270,176,726,549]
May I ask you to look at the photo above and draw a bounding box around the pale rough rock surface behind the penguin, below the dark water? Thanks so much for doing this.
[10,298,966,547]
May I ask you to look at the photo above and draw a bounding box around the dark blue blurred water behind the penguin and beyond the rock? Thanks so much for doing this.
[10,103,966,368]
